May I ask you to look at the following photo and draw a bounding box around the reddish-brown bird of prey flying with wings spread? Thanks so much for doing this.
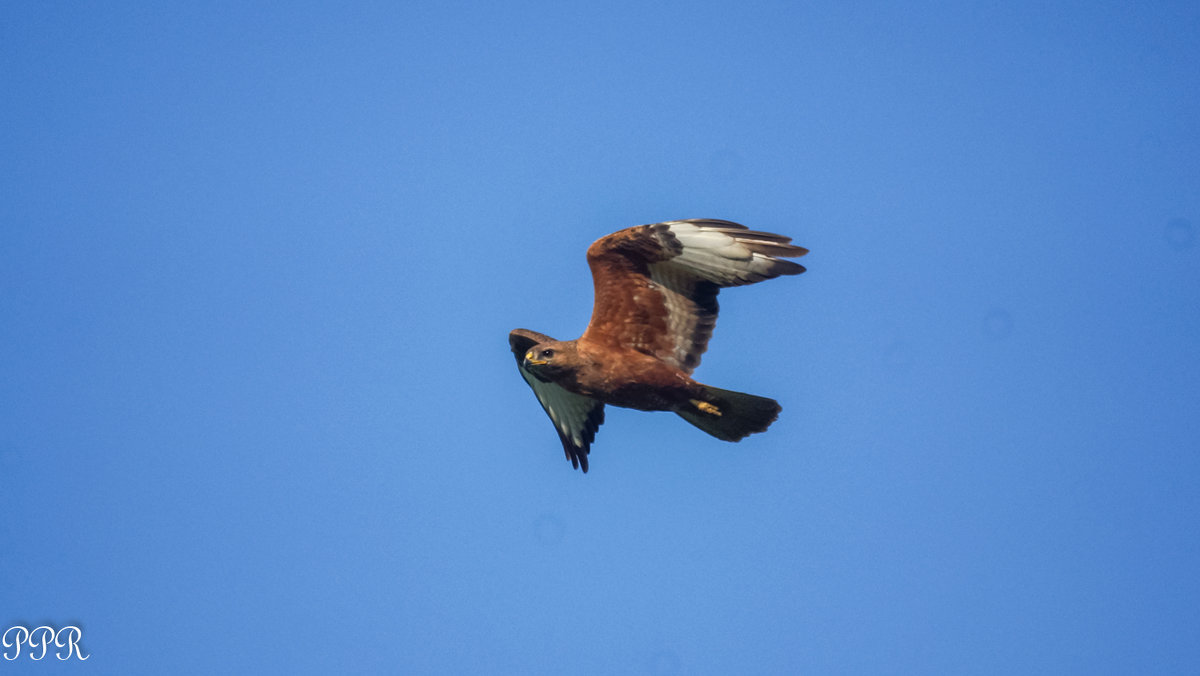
[509,219,808,472]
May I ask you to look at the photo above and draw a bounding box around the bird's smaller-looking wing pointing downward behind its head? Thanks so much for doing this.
[509,329,604,473]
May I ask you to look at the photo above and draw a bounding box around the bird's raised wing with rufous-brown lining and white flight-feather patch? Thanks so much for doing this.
[580,219,809,373]
